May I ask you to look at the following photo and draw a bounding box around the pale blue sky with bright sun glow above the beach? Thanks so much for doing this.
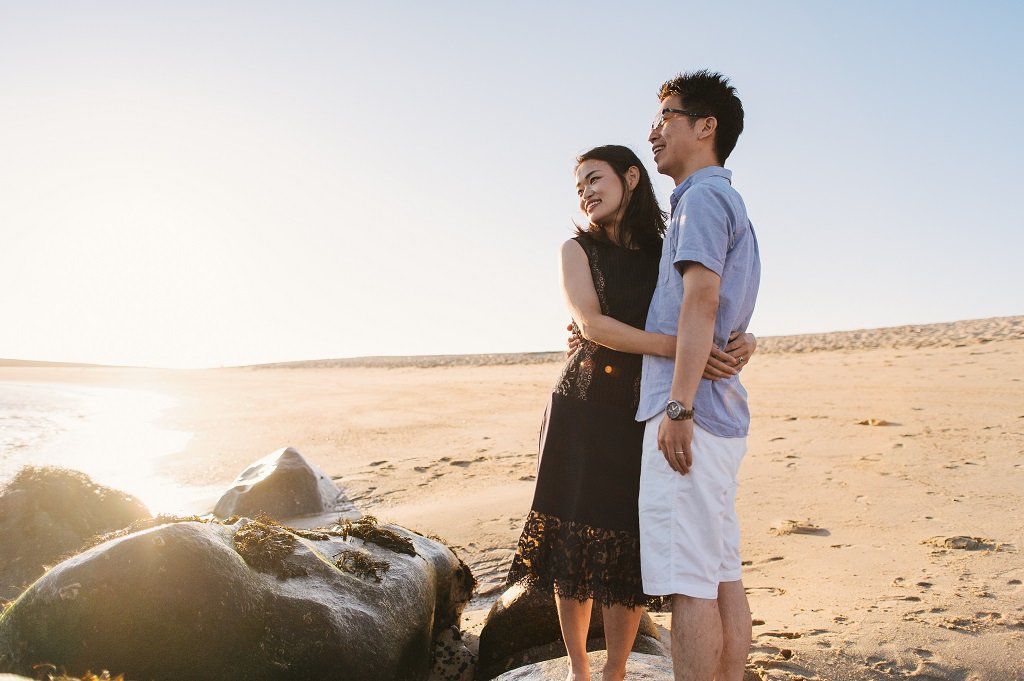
[0,0,1024,367]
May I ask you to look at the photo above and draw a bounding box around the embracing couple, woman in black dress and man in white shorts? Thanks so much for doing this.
[508,71,761,681]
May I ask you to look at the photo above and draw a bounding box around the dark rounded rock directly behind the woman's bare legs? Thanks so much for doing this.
[477,584,666,680]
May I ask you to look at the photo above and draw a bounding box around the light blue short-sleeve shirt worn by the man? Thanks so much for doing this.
[637,166,761,437]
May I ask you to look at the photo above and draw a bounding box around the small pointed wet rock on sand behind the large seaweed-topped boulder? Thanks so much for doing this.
[213,446,341,520]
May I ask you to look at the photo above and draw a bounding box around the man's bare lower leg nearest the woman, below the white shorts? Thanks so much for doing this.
[672,594,722,681]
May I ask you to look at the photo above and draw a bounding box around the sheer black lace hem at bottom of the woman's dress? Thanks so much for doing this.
[506,511,666,610]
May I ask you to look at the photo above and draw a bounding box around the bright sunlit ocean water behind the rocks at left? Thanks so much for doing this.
[0,382,219,513]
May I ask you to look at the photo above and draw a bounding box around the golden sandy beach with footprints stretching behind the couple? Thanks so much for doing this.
[0,316,1024,680]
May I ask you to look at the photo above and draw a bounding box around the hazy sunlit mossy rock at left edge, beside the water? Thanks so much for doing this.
[0,466,150,599]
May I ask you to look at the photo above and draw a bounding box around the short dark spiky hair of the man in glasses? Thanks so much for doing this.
[657,69,743,165]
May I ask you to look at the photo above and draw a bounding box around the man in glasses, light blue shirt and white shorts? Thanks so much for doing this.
[637,71,761,681]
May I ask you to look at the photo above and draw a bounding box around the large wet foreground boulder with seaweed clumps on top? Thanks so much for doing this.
[0,516,474,681]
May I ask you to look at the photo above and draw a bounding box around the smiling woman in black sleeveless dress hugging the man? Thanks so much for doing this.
[507,145,754,681]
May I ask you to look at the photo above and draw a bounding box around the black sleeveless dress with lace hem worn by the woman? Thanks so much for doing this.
[506,233,663,607]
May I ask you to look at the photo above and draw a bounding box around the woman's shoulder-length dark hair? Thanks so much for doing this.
[575,144,668,250]
